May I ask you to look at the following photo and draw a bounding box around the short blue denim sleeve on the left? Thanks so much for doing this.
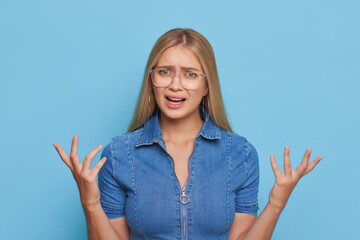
[98,141,126,219]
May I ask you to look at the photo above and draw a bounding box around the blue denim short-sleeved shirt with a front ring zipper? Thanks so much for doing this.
[98,106,259,240]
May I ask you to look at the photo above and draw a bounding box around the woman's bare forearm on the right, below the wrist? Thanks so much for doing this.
[238,202,282,240]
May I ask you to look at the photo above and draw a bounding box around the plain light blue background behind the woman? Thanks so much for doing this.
[0,0,360,240]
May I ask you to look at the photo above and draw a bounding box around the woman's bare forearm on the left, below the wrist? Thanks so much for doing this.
[83,203,122,240]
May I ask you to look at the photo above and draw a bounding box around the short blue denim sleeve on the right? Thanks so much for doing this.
[235,142,259,215]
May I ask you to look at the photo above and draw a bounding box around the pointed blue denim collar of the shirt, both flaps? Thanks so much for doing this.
[136,105,221,147]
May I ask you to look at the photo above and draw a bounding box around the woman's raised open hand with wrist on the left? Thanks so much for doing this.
[53,135,106,208]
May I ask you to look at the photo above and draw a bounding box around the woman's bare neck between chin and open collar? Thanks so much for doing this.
[159,111,204,143]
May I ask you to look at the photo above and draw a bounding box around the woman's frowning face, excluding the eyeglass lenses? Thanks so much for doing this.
[152,45,208,119]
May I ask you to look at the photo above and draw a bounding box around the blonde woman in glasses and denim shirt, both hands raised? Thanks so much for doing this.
[54,29,322,239]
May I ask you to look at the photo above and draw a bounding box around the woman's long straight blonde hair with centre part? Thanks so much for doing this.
[128,28,232,132]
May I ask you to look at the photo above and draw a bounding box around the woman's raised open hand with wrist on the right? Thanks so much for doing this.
[269,146,322,212]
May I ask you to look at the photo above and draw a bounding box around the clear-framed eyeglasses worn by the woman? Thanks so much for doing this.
[149,68,206,90]
